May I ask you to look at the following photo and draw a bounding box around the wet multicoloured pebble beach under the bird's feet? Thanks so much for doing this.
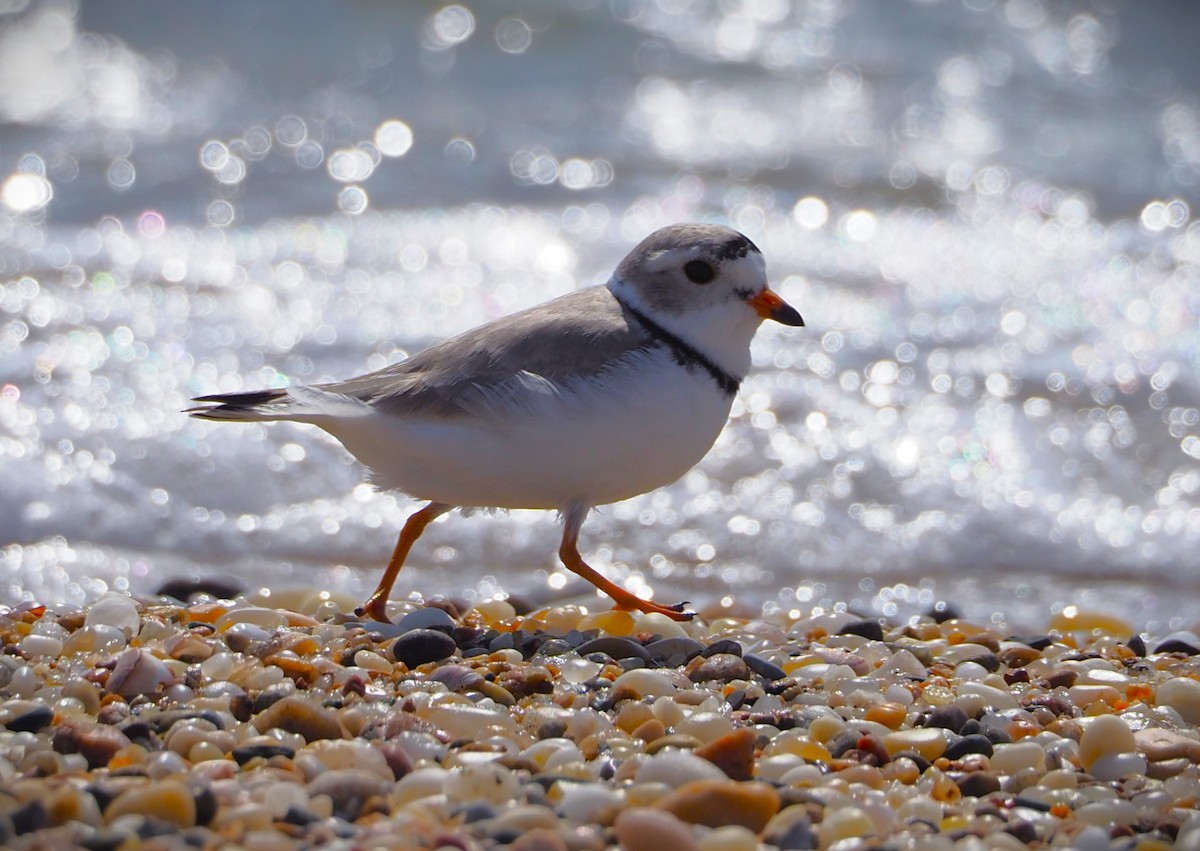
[0,591,1200,851]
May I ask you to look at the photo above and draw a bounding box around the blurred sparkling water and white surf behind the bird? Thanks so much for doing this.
[0,0,1200,629]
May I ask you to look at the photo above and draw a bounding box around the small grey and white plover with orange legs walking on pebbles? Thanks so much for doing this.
[186,223,804,623]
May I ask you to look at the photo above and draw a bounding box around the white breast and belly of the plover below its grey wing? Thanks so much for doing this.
[326,359,732,509]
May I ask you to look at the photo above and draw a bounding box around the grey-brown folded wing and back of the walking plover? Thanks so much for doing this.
[318,287,650,416]
